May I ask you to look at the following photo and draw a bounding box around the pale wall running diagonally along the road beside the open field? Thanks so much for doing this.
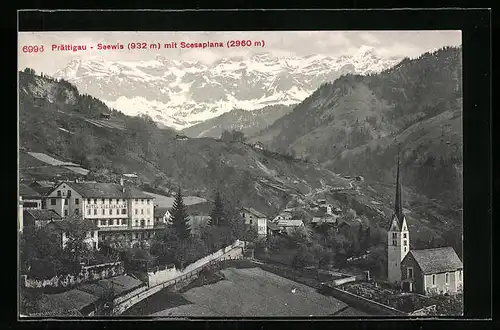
[113,241,243,315]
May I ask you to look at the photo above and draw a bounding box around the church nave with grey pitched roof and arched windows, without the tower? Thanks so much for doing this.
[401,247,463,294]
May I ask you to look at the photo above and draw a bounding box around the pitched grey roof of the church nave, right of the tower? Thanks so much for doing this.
[405,246,463,274]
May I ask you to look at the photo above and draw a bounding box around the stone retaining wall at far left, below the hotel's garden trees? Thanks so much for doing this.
[21,261,125,289]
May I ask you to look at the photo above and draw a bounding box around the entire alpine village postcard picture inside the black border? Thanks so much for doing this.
[17,30,467,321]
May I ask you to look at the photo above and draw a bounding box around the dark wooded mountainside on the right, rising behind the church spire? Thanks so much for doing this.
[252,47,462,209]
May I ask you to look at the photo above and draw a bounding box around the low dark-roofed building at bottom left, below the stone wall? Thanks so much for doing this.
[38,289,99,316]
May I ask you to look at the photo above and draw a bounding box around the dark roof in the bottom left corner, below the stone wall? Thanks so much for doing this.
[39,289,99,315]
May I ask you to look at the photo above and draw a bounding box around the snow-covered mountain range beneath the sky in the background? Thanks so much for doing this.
[54,46,399,129]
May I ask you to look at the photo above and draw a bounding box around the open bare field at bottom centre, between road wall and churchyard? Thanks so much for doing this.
[153,268,347,317]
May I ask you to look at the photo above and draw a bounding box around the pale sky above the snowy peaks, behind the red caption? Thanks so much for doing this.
[18,31,462,75]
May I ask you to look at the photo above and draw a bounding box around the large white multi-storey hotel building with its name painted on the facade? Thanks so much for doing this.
[47,180,159,245]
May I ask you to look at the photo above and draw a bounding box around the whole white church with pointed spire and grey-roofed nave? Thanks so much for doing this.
[387,156,463,294]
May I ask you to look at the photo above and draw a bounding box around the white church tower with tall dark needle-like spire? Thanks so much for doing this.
[387,155,410,283]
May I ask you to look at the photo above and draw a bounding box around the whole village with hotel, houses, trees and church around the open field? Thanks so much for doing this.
[19,157,463,316]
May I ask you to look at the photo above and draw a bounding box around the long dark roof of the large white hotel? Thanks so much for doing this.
[53,182,154,199]
